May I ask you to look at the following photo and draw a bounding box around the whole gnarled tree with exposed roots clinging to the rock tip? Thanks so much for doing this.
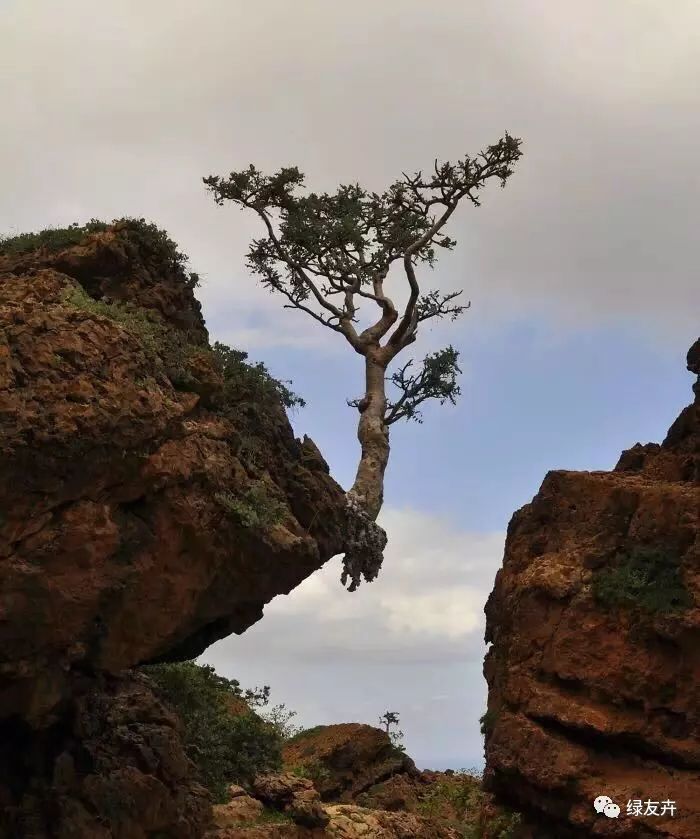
[203,133,521,591]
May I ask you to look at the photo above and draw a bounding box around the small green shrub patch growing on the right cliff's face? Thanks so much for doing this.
[592,547,693,613]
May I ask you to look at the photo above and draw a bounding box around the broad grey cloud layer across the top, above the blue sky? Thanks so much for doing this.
[0,0,700,346]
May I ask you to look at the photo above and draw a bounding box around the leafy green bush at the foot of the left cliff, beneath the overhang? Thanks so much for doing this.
[141,661,282,802]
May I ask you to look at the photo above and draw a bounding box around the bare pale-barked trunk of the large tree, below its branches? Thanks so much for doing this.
[348,350,389,521]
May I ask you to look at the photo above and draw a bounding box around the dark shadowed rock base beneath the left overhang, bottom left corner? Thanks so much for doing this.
[0,674,211,839]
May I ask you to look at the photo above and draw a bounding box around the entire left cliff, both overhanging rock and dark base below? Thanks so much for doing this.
[0,221,345,839]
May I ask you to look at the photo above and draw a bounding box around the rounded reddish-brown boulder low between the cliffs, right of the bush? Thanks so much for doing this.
[284,723,417,802]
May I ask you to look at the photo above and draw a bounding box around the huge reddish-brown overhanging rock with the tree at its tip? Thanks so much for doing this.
[0,225,344,721]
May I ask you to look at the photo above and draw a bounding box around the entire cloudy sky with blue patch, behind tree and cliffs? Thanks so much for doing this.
[0,0,700,768]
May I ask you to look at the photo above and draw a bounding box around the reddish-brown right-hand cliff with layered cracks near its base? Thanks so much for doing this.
[484,341,700,839]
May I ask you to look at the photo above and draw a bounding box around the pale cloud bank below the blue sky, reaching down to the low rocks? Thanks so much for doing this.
[202,508,505,768]
